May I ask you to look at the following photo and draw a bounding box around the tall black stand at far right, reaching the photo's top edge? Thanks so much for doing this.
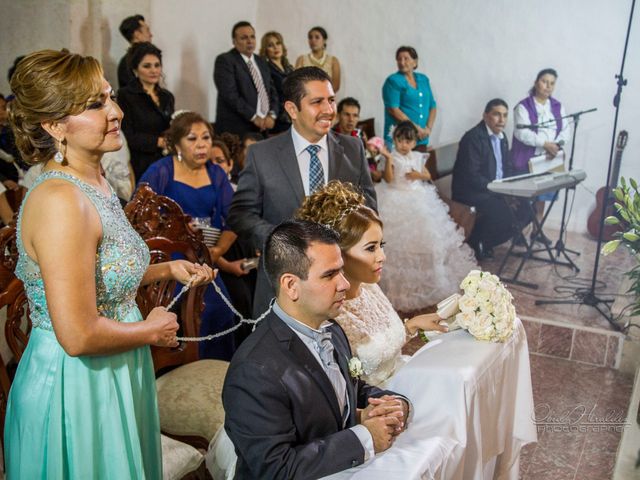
[535,0,636,331]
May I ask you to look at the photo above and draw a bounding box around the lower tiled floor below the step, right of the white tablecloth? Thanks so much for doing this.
[520,354,635,480]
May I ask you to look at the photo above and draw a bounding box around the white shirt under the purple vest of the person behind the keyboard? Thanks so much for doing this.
[513,99,571,155]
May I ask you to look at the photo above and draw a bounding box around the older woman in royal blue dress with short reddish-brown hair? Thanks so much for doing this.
[140,112,242,360]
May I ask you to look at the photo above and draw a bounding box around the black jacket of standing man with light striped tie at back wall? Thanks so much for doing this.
[213,48,280,136]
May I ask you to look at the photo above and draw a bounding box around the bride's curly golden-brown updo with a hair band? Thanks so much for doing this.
[296,180,382,252]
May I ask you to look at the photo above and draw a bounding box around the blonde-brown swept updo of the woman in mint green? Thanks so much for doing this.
[9,50,103,164]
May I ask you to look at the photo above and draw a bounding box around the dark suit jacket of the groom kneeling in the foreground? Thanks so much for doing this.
[222,313,393,480]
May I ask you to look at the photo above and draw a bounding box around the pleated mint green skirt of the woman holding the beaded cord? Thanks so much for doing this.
[4,308,162,480]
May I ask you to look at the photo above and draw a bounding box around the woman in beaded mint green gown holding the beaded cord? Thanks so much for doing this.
[4,50,213,480]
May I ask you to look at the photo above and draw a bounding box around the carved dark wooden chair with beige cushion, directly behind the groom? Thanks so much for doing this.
[125,185,229,450]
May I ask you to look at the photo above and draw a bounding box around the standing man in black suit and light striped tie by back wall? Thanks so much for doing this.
[213,21,279,138]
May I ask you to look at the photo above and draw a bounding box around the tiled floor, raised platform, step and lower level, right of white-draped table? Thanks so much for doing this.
[482,227,635,480]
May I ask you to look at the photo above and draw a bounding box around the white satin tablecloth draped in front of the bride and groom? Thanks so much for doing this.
[326,320,537,480]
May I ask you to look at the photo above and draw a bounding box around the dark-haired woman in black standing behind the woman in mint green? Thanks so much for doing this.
[118,42,175,181]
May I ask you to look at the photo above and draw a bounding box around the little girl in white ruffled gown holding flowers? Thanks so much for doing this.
[376,121,478,312]
